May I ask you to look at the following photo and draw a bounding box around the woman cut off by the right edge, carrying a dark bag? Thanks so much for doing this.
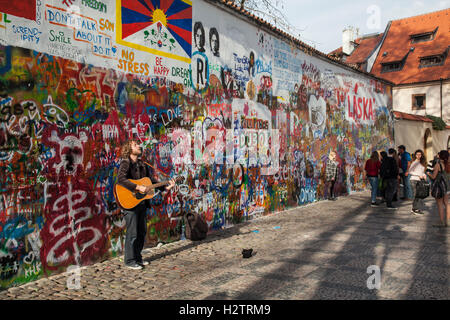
[428,150,450,228]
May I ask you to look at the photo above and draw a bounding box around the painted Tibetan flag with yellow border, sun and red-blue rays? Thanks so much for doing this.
[117,0,192,62]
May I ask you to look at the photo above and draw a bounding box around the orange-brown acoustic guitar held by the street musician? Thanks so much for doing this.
[114,177,183,210]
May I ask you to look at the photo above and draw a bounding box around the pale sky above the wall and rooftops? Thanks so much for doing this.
[283,0,450,53]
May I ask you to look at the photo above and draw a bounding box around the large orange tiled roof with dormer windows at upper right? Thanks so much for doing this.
[371,9,450,84]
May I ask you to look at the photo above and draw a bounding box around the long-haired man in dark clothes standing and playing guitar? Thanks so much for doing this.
[117,140,175,270]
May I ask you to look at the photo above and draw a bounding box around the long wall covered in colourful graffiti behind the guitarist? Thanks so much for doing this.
[0,0,393,288]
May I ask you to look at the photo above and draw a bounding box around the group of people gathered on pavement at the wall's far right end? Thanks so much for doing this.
[364,145,450,227]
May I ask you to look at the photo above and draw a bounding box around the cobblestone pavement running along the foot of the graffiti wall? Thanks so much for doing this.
[0,192,450,300]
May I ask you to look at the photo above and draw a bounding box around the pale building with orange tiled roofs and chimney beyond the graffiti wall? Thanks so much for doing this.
[330,9,450,158]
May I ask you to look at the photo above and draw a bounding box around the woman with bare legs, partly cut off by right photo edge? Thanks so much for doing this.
[428,150,450,228]
